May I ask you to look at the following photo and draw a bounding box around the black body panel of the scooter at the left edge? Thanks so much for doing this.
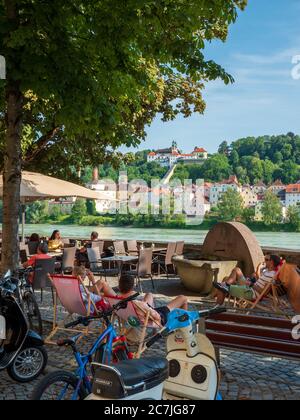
[0,296,28,370]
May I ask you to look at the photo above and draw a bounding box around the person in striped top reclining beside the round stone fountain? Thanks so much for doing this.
[214,255,281,305]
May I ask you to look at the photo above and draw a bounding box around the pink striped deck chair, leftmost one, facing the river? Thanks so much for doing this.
[45,275,98,344]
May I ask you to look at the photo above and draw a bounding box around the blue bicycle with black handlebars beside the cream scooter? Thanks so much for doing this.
[31,294,139,401]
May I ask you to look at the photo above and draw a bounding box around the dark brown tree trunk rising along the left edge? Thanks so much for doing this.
[1,0,23,272]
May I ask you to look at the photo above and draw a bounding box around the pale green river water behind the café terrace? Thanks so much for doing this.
[21,225,300,251]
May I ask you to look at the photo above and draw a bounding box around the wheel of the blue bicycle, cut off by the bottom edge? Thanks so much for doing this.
[30,371,87,401]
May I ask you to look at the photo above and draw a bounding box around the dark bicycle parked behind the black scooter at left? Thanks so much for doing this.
[15,267,43,336]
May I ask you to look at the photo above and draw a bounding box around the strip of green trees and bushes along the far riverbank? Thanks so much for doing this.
[0,194,300,232]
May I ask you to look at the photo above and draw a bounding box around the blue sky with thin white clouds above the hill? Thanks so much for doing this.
[132,0,300,153]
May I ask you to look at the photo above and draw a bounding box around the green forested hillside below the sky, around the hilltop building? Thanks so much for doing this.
[82,133,300,185]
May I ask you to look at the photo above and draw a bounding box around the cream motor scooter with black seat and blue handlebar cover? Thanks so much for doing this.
[87,307,226,400]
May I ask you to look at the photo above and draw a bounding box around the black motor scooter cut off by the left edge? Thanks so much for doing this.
[0,272,48,383]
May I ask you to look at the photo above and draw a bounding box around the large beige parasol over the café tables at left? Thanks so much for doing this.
[0,171,117,241]
